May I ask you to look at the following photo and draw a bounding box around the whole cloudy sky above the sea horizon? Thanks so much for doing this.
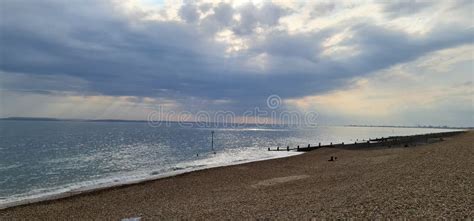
[0,0,474,126]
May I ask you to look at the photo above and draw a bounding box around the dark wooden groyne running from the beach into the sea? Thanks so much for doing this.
[268,131,465,152]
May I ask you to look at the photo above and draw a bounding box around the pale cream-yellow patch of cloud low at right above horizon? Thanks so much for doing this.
[287,45,474,126]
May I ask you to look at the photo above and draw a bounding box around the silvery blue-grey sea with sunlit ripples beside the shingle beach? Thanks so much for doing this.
[0,121,460,205]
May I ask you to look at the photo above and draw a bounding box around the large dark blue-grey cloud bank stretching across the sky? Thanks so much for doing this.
[0,0,473,108]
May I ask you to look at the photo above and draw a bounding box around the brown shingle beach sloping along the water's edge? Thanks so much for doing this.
[0,131,474,220]
